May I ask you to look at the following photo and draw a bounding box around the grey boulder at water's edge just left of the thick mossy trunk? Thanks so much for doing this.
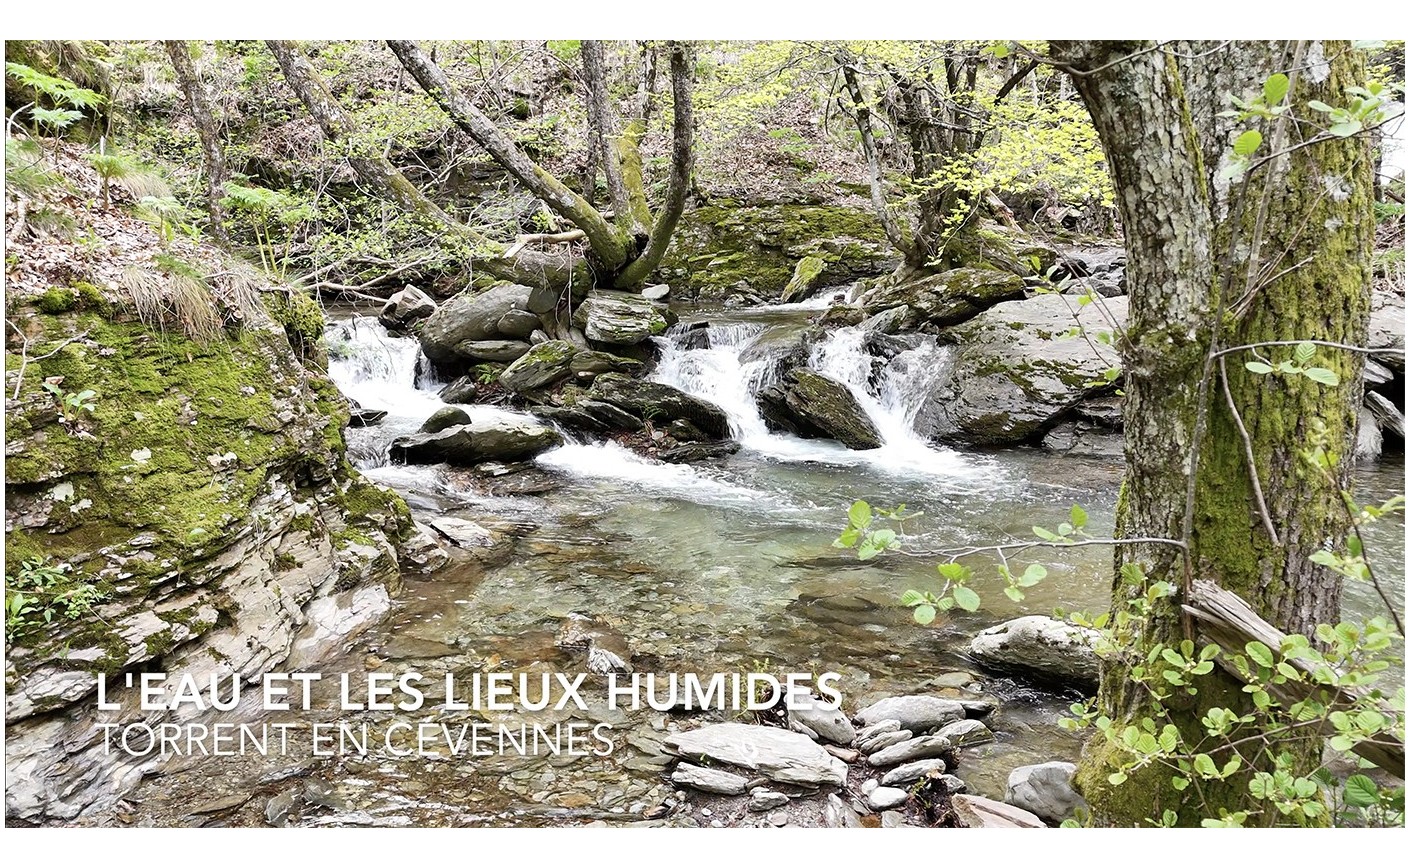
[969,614,1098,689]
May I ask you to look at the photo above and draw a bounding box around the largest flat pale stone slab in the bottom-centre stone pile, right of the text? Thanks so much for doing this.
[661,723,847,786]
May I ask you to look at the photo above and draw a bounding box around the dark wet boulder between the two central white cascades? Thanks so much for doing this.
[756,368,881,450]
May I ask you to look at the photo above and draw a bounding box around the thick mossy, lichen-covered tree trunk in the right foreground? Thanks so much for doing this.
[1052,42,1372,824]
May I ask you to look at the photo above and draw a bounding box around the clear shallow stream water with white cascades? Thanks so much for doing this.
[121,303,1404,824]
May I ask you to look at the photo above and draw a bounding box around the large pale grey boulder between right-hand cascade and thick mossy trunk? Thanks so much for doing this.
[933,293,1127,447]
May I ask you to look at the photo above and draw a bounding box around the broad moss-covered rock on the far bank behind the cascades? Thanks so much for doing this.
[658,200,900,297]
